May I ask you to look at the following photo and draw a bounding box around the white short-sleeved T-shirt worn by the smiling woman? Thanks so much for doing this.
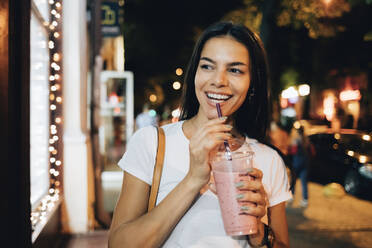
[119,121,292,248]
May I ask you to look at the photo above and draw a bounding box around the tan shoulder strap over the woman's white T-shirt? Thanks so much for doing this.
[147,127,165,212]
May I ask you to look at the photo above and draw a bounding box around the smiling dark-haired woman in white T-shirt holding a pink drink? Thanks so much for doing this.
[109,23,291,248]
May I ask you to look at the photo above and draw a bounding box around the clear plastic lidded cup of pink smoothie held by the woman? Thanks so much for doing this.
[211,141,257,236]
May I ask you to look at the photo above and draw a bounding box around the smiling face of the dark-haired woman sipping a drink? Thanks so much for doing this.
[195,36,250,119]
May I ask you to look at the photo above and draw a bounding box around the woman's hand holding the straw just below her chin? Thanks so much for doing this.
[188,117,232,187]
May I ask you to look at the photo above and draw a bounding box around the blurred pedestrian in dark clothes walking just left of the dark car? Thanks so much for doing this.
[289,126,312,207]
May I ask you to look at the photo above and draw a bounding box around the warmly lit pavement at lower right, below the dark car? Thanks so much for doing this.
[287,182,372,248]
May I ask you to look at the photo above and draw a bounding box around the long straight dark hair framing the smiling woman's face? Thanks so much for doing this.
[180,22,269,141]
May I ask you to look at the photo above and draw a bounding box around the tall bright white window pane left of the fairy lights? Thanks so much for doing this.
[30,9,49,209]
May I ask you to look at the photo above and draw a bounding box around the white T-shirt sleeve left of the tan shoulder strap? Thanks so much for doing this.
[118,126,157,185]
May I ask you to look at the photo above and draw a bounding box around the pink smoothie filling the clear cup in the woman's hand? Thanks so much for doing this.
[212,158,257,236]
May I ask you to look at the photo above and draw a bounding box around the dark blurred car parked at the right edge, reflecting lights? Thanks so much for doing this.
[308,129,372,195]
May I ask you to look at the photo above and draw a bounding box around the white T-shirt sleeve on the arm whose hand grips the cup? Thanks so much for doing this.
[269,152,292,207]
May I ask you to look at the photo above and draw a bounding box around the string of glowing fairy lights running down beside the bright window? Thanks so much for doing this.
[30,0,63,230]
